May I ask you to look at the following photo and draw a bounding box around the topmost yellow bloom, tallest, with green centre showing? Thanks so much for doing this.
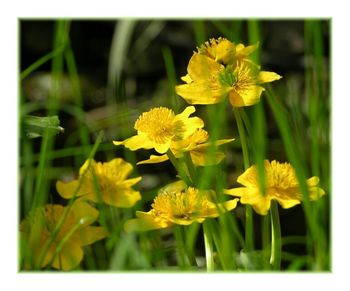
[175,38,281,107]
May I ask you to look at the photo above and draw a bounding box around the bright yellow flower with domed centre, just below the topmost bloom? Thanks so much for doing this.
[113,106,204,154]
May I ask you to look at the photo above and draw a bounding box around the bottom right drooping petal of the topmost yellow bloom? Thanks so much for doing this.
[229,85,264,107]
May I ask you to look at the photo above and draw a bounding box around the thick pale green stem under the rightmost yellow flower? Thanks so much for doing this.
[270,201,282,270]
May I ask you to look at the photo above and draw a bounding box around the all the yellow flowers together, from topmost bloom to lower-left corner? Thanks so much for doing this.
[20,38,325,270]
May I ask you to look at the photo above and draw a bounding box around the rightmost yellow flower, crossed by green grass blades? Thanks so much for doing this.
[225,160,325,215]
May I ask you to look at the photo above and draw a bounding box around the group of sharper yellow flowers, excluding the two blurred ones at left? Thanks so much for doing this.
[114,38,325,231]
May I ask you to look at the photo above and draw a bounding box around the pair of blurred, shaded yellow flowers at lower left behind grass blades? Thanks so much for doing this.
[20,158,141,270]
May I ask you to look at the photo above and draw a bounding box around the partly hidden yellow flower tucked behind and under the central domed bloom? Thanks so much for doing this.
[137,129,234,166]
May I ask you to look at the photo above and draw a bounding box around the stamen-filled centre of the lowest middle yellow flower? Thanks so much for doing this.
[152,187,210,219]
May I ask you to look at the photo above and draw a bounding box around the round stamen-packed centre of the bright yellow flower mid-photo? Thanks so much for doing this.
[135,107,184,144]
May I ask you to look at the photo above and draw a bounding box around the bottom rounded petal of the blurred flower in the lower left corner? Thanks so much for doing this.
[52,241,84,271]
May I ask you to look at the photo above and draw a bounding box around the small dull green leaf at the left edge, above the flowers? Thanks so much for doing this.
[23,115,64,138]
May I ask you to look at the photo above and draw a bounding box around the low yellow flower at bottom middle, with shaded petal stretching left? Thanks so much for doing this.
[124,181,238,231]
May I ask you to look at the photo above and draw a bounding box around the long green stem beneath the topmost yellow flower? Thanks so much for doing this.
[233,108,254,252]
